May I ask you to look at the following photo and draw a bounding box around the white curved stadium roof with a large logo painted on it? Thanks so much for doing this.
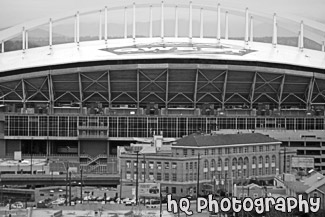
[0,38,325,73]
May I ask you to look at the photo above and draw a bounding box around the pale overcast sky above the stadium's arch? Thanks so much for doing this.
[0,0,325,28]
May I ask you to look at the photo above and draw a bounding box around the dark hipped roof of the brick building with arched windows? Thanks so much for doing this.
[173,133,280,147]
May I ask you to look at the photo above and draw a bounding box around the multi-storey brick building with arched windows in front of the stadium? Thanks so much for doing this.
[120,133,281,196]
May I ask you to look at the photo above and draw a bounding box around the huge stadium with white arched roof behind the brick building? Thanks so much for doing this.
[0,2,325,179]
